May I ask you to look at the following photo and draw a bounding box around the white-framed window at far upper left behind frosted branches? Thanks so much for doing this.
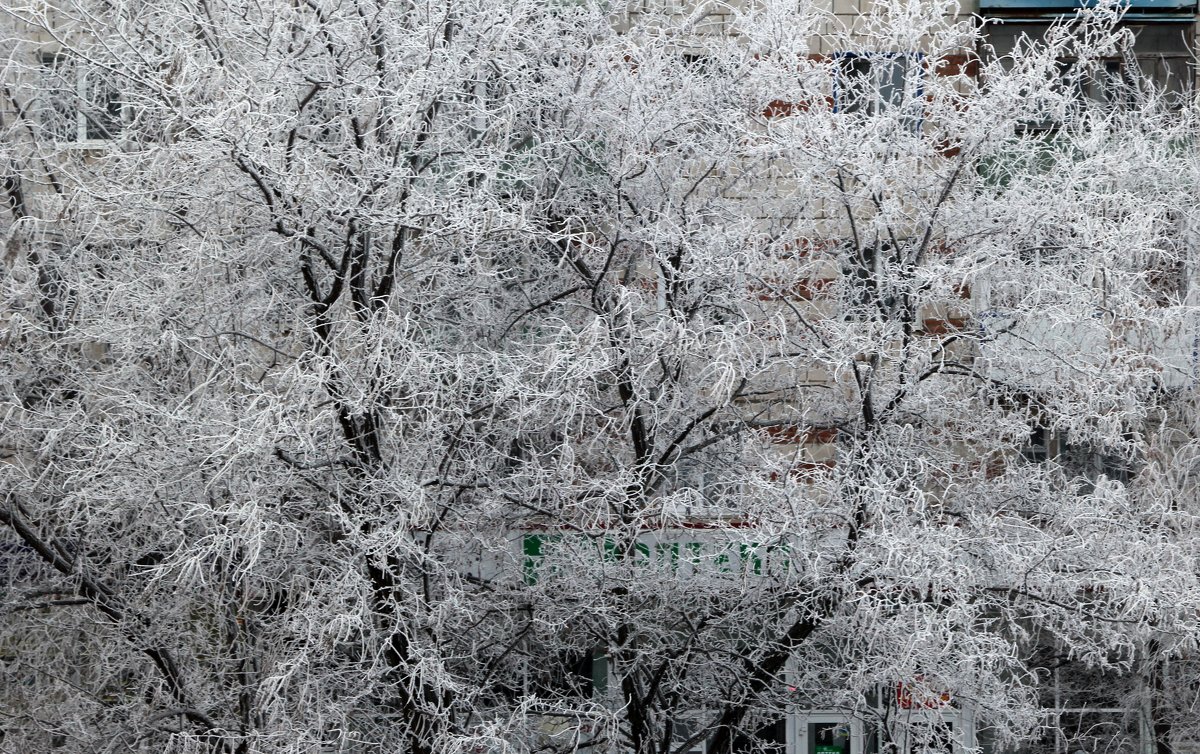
[42,53,121,143]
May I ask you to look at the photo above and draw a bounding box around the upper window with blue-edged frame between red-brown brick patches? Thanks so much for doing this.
[834,53,920,127]
